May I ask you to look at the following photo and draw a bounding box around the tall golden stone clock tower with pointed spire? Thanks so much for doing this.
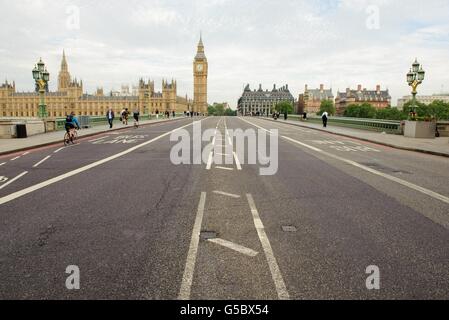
[193,37,208,113]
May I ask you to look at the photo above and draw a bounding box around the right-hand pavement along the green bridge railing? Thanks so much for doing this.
[260,117,449,157]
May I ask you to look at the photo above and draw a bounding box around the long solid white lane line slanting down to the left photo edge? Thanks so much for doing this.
[0,119,203,205]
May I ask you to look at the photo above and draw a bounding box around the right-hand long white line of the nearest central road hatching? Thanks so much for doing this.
[246,194,290,300]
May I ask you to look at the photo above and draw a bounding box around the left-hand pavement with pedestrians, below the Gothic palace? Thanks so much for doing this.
[0,117,186,155]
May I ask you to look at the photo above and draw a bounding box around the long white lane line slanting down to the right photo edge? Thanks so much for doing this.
[242,119,449,204]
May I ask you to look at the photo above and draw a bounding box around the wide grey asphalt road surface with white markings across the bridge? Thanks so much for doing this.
[0,117,449,300]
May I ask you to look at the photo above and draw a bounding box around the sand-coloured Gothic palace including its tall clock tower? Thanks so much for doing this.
[0,39,208,118]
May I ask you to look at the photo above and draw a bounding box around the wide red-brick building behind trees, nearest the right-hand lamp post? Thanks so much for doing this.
[335,85,391,115]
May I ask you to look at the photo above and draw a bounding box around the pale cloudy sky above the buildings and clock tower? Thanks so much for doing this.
[0,0,449,107]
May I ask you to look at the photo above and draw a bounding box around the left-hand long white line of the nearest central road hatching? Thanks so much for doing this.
[178,192,207,300]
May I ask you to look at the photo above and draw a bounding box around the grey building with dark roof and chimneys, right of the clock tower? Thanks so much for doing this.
[237,84,295,115]
